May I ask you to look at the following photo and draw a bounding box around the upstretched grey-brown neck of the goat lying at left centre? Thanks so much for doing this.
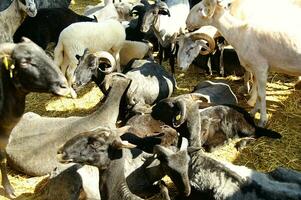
[88,77,130,128]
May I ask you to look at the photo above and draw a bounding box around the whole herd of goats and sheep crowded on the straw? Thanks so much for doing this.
[0,0,301,200]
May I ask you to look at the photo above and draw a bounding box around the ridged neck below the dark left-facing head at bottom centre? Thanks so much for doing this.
[99,150,142,200]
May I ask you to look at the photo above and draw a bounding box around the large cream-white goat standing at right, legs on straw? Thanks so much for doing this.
[186,0,301,127]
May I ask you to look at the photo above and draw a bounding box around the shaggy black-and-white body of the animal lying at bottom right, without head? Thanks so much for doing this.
[173,147,301,200]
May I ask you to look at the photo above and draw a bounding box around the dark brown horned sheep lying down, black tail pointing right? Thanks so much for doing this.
[151,93,281,151]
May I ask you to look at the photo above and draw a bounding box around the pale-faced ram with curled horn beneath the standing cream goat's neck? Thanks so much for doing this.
[177,26,244,76]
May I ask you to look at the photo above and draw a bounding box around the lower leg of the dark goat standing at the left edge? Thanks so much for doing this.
[0,149,16,199]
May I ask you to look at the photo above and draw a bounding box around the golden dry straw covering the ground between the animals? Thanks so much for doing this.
[0,0,301,200]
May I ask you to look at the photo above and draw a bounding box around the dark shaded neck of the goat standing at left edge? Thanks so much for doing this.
[0,64,27,135]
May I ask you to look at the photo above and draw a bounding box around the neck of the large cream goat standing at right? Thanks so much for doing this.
[211,5,248,52]
